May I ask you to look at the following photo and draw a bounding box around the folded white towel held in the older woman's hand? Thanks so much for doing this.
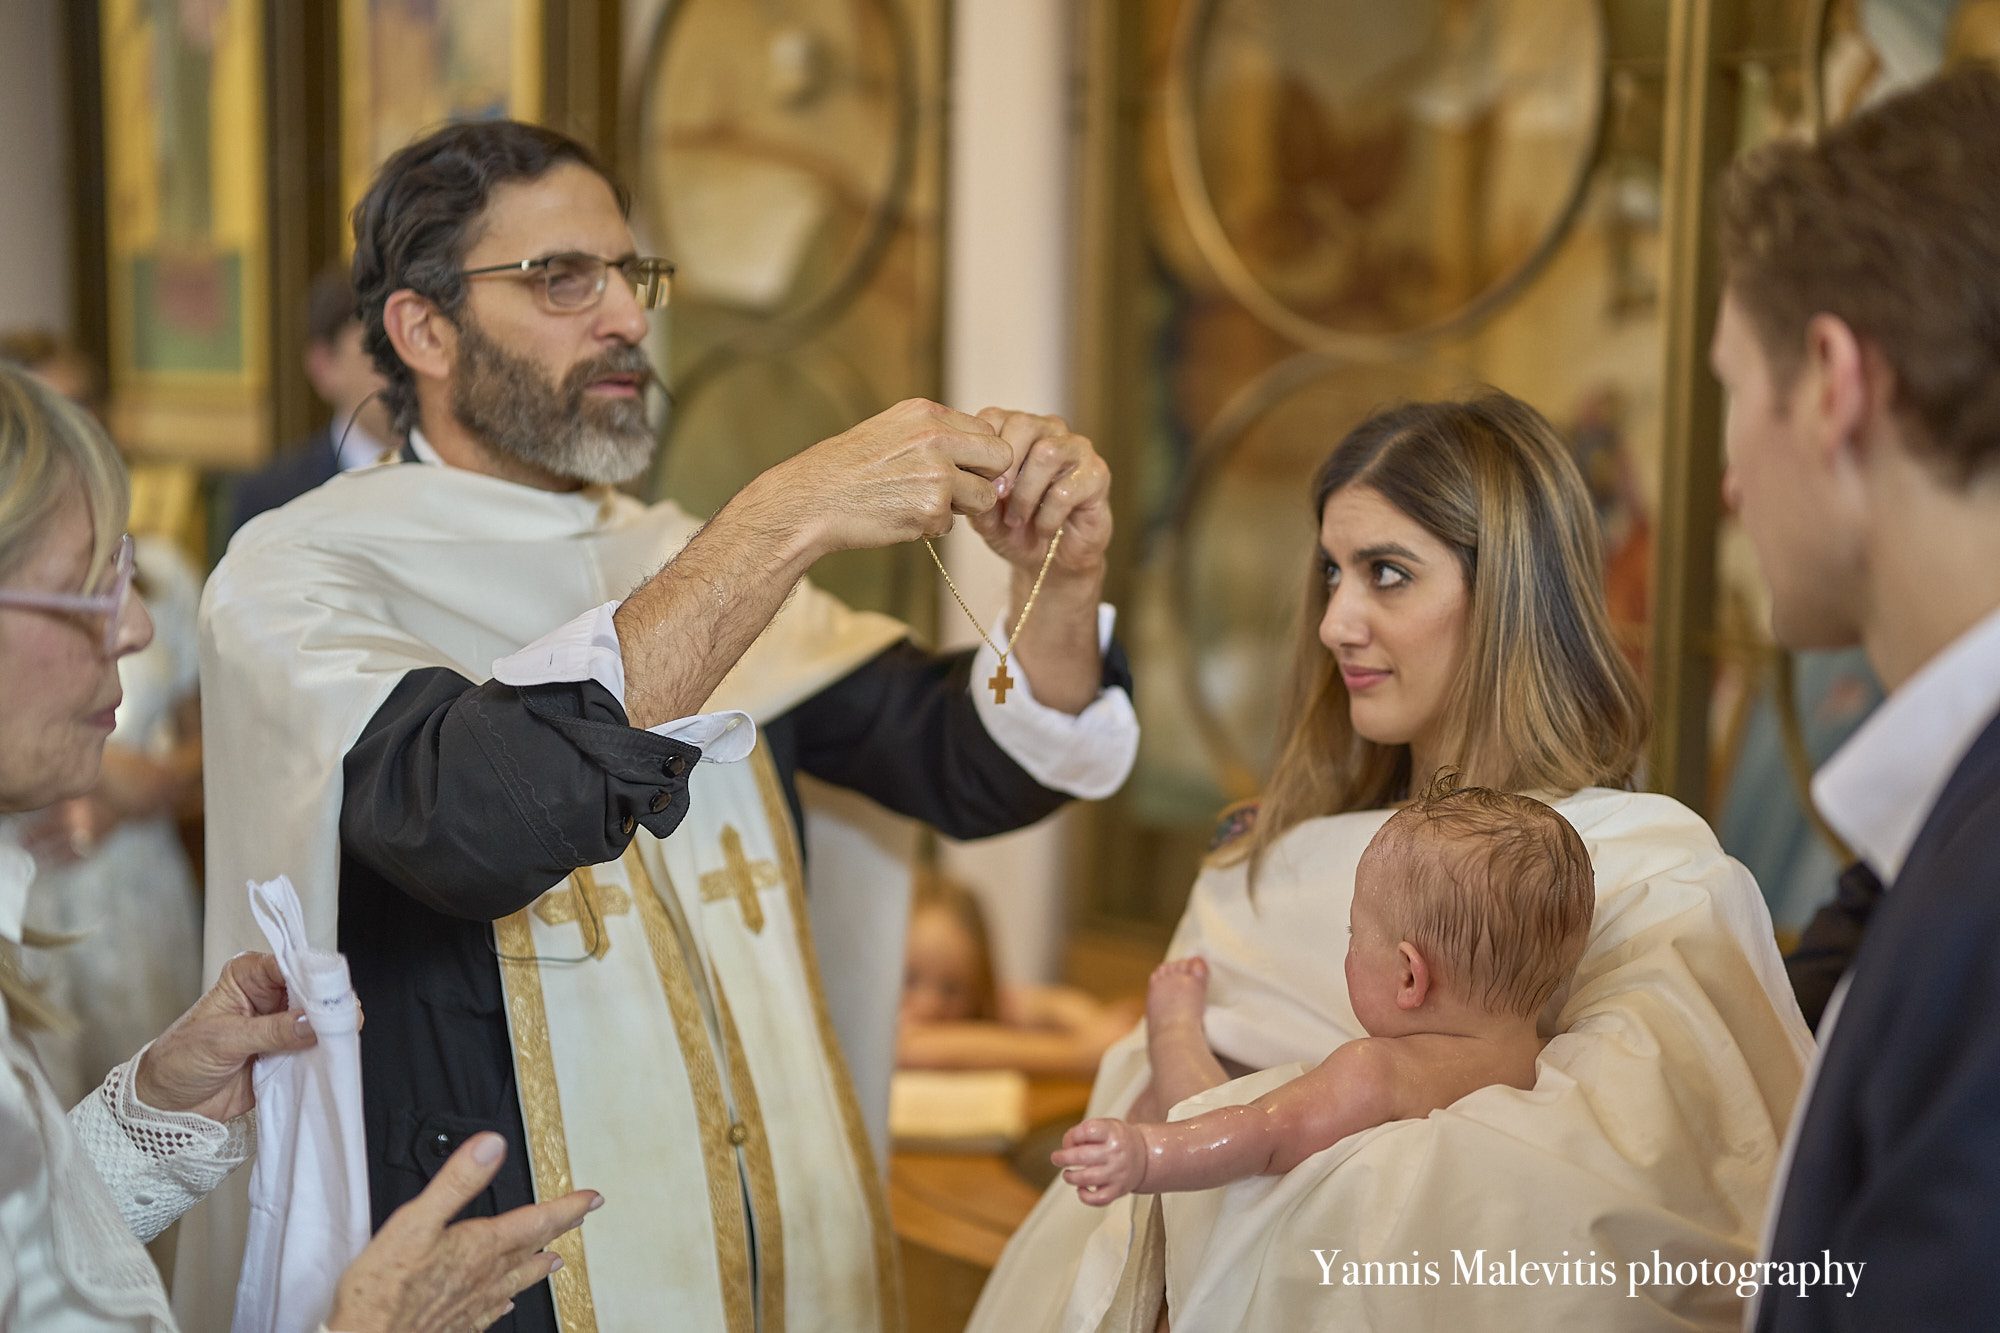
[230,875,368,1333]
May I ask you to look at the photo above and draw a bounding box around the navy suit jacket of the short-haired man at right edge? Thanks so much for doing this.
[1756,700,2000,1333]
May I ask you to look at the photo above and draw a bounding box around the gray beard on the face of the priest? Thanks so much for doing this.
[452,318,654,486]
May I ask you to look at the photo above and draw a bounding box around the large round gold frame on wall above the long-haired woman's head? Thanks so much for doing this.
[1166,0,1610,362]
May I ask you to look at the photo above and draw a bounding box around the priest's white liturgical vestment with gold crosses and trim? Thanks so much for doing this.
[176,464,904,1333]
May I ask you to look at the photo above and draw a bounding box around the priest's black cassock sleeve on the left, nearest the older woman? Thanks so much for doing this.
[340,669,702,921]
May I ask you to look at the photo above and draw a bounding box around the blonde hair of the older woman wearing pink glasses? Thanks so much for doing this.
[0,362,132,1029]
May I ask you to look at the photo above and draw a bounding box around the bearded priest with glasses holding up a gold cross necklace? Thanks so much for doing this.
[176,122,1138,1333]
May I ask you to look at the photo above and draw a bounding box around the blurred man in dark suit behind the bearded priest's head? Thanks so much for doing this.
[230,266,390,536]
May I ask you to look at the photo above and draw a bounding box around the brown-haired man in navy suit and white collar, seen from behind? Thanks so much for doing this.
[1712,70,2000,1333]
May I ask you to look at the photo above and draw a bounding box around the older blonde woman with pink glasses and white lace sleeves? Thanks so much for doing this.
[0,364,602,1333]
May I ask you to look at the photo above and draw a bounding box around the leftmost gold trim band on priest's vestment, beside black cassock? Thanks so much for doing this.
[494,909,598,1333]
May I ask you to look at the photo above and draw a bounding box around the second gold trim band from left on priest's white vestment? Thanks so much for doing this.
[624,841,756,1333]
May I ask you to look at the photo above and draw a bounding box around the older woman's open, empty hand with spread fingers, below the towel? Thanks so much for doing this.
[326,1133,604,1333]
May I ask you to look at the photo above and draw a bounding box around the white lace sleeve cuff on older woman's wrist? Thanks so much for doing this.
[70,1051,256,1241]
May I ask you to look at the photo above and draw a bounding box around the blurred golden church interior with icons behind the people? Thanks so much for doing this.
[0,0,2000,1329]
